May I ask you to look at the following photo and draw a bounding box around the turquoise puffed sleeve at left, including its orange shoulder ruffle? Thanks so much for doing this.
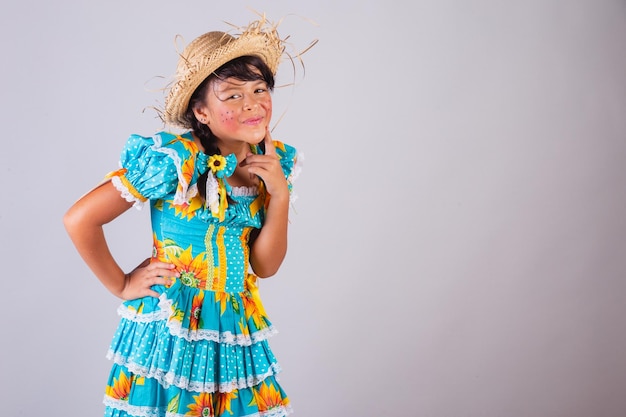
[107,133,197,208]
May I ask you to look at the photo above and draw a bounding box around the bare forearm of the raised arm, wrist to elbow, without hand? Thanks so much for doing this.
[250,194,289,278]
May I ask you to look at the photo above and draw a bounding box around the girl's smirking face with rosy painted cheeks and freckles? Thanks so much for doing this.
[195,72,272,148]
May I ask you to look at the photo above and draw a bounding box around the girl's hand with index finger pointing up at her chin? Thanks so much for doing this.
[240,129,289,198]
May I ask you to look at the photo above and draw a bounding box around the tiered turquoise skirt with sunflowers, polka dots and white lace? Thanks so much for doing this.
[104,274,291,417]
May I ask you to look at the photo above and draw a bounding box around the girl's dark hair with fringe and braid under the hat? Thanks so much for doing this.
[184,55,274,198]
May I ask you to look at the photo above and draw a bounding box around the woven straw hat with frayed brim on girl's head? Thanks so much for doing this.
[163,19,285,129]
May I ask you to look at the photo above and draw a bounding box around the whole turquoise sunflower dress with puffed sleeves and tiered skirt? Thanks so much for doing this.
[104,132,297,417]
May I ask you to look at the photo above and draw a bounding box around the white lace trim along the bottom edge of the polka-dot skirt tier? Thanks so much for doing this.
[107,349,282,392]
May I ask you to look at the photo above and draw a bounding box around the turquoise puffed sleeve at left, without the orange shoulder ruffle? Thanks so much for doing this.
[107,135,187,208]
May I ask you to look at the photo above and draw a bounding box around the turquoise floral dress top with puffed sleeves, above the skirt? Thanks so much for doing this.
[109,132,296,293]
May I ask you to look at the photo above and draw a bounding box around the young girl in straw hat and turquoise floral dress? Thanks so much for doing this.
[64,20,304,417]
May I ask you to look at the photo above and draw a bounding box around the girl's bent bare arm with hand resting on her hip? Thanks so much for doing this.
[63,181,175,300]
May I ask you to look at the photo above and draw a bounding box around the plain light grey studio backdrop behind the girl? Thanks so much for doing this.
[0,0,626,417]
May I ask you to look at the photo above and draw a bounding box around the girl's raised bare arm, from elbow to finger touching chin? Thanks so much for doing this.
[243,131,289,278]
